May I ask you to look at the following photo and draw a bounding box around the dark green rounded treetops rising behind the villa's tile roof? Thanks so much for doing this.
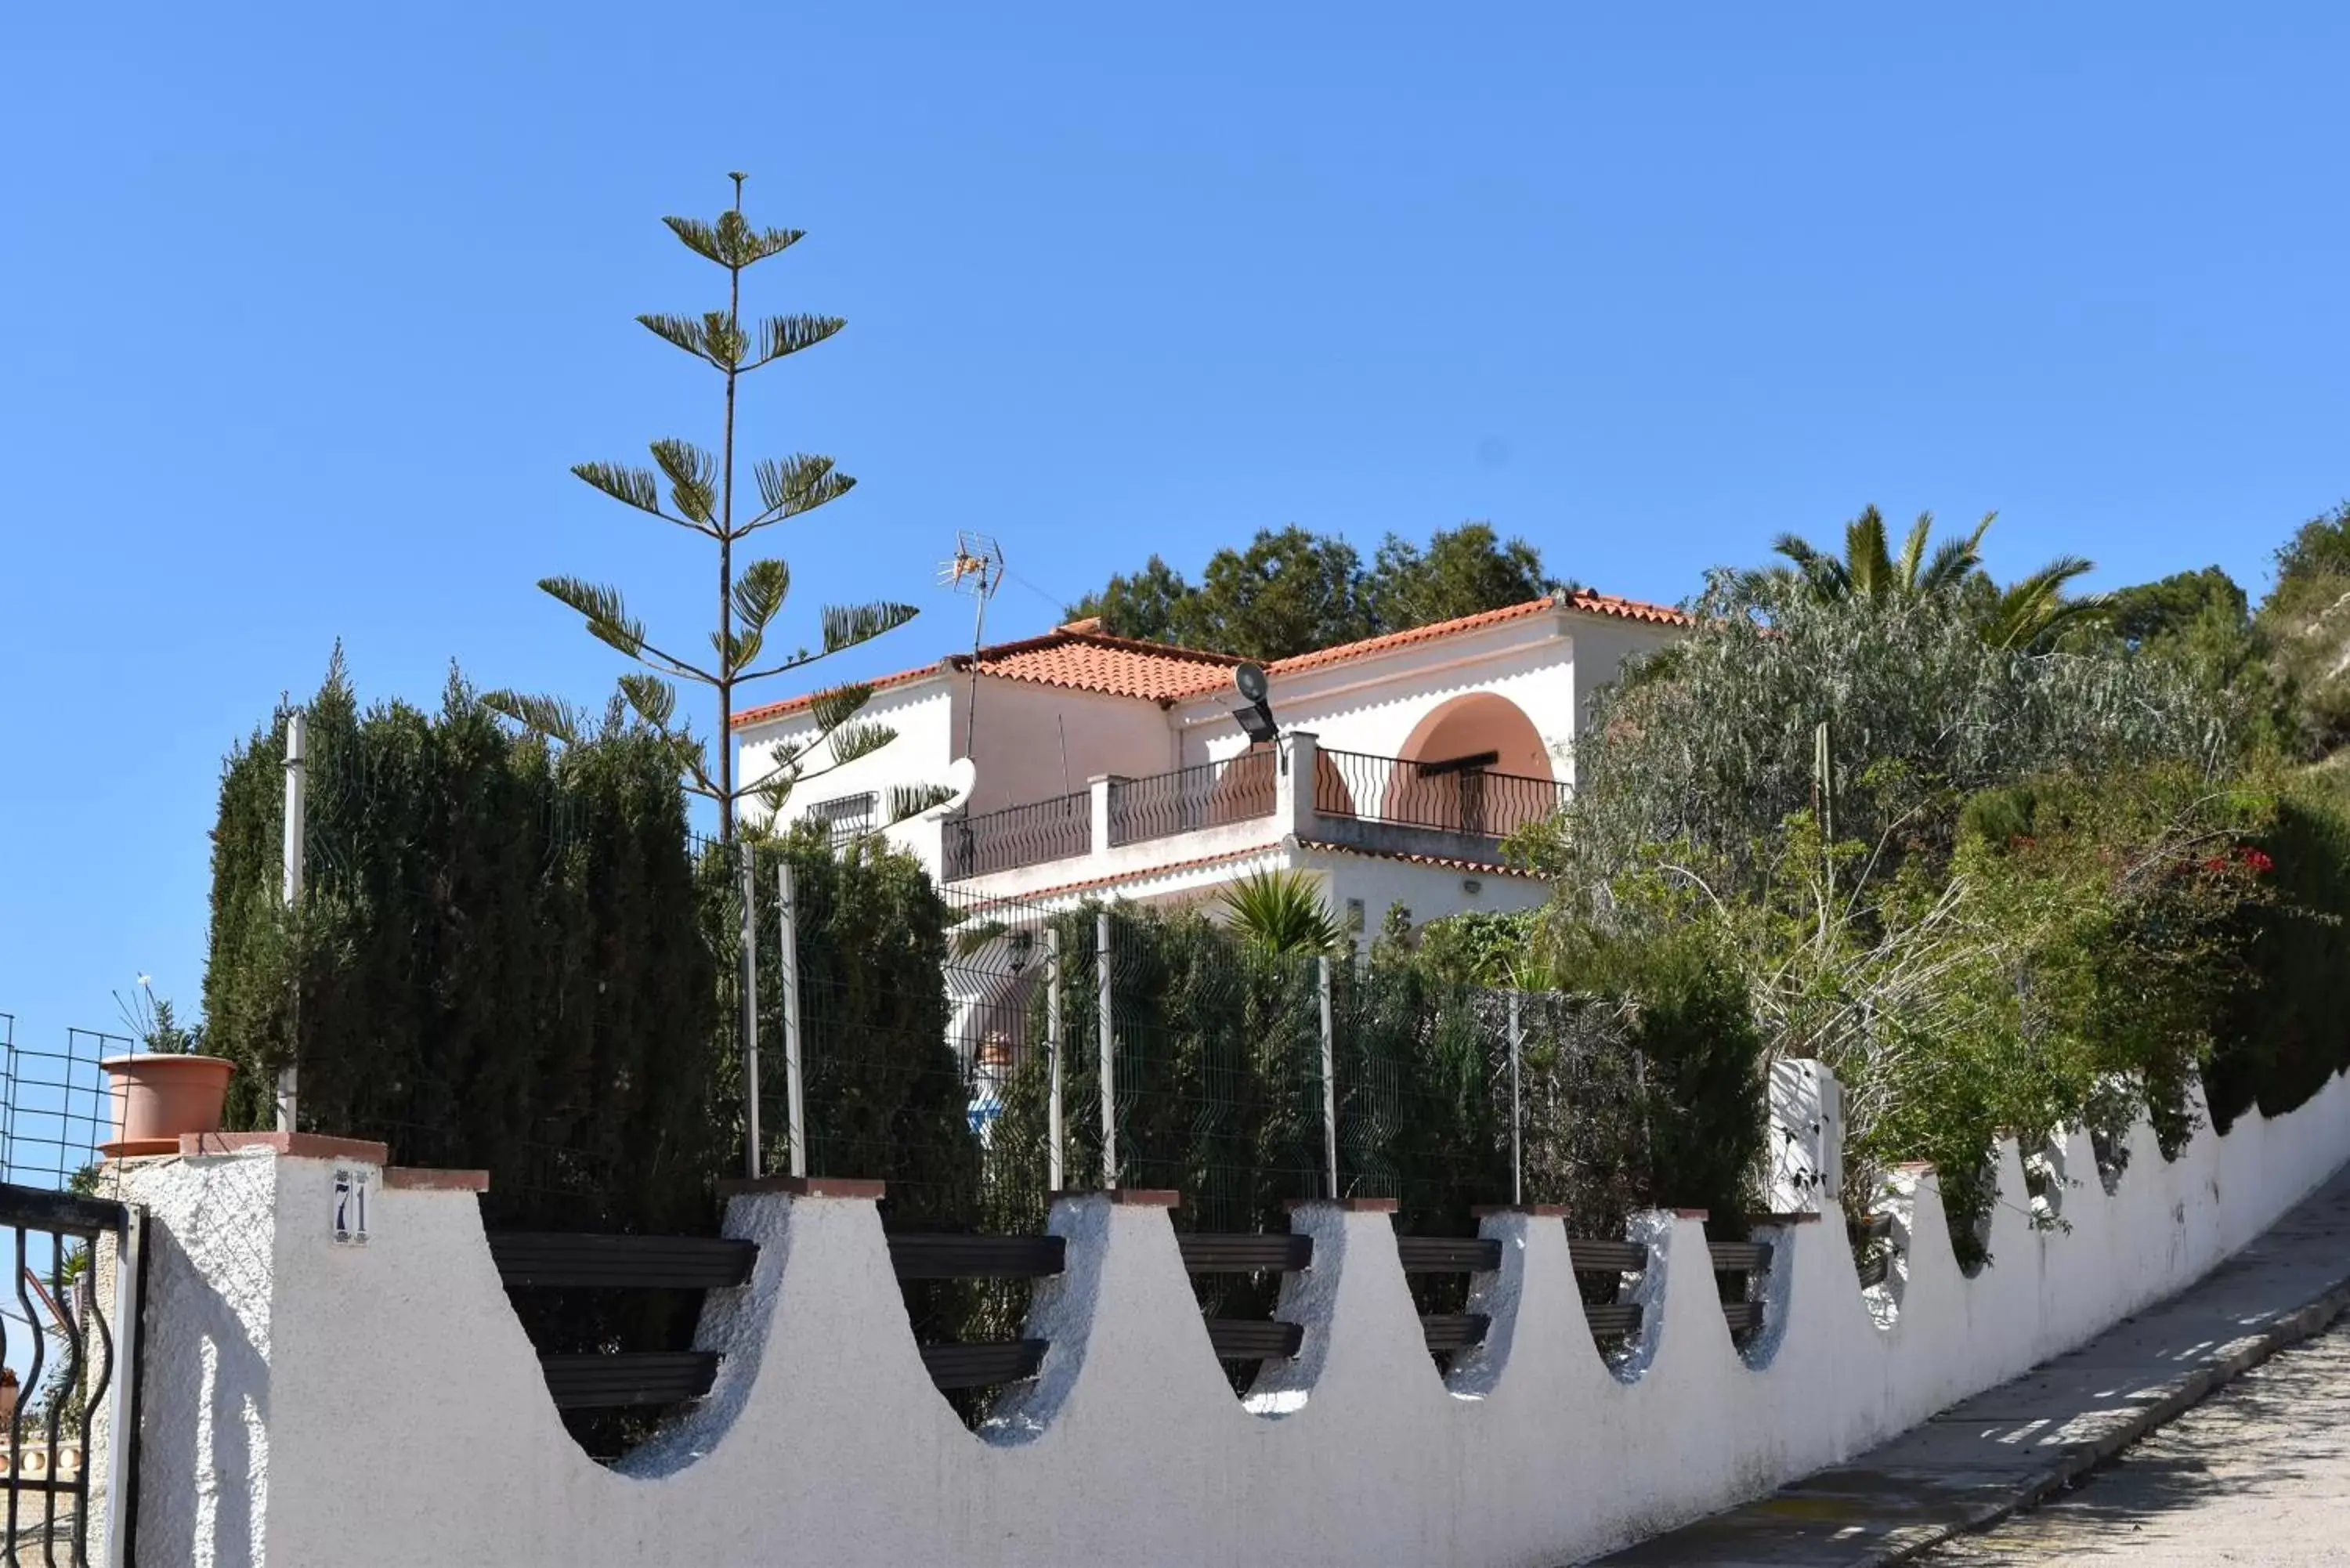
[1069,522,1551,660]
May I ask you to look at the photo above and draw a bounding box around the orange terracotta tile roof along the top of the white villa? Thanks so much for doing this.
[733,592,1690,728]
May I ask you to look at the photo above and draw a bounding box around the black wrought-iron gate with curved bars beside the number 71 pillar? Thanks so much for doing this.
[0,1183,139,1568]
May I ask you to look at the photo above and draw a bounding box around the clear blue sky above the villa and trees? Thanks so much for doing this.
[0,2,2350,1062]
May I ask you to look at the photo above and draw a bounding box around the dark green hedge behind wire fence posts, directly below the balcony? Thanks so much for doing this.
[982,893,1762,1259]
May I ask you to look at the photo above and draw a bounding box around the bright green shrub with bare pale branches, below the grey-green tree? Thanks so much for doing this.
[1551,764,2268,1255]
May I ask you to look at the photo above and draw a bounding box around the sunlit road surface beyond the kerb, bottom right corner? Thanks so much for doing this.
[1915,1319,2350,1568]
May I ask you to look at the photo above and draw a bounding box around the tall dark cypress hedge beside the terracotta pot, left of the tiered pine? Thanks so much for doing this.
[204,660,721,1230]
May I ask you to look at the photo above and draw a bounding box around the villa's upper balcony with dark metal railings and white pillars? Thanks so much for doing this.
[940,733,1567,891]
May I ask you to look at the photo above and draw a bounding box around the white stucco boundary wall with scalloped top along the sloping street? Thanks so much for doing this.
[129,1079,2350,1568]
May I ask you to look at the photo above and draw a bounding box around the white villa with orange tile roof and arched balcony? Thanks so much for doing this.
[736,592,1685,929]
